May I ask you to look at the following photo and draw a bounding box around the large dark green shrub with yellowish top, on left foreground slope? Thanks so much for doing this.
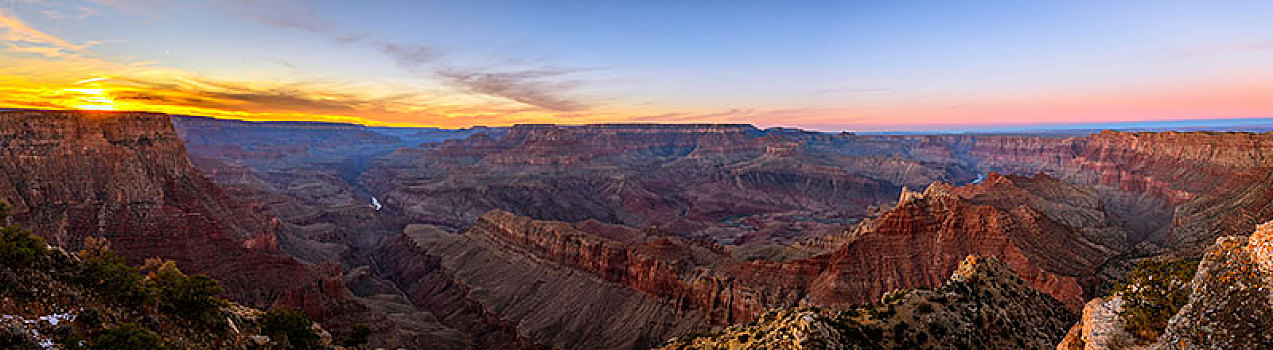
[141,258,227,325]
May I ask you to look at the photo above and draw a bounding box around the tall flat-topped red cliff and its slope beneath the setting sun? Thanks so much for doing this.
[0,112,355,319]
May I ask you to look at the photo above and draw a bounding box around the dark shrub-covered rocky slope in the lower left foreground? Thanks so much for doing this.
[0,226,338,350]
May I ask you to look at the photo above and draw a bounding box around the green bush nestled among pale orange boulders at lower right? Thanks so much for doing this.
[1114,260,1198,340]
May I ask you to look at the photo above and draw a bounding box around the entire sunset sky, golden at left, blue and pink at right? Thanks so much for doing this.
[0,0,1273,131]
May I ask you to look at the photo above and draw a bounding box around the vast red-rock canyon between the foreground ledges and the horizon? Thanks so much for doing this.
[0,111,1273,349]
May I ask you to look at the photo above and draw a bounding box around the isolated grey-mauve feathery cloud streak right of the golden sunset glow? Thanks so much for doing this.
[438,69,588,112]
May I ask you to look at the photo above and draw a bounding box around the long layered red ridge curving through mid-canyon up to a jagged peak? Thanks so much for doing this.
[376,174,1116,347]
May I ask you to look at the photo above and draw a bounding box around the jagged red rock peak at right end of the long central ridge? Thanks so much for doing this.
[810,173,1118,309]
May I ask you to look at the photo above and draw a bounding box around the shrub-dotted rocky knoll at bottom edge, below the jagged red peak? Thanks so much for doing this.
[662,256,1073,349]
